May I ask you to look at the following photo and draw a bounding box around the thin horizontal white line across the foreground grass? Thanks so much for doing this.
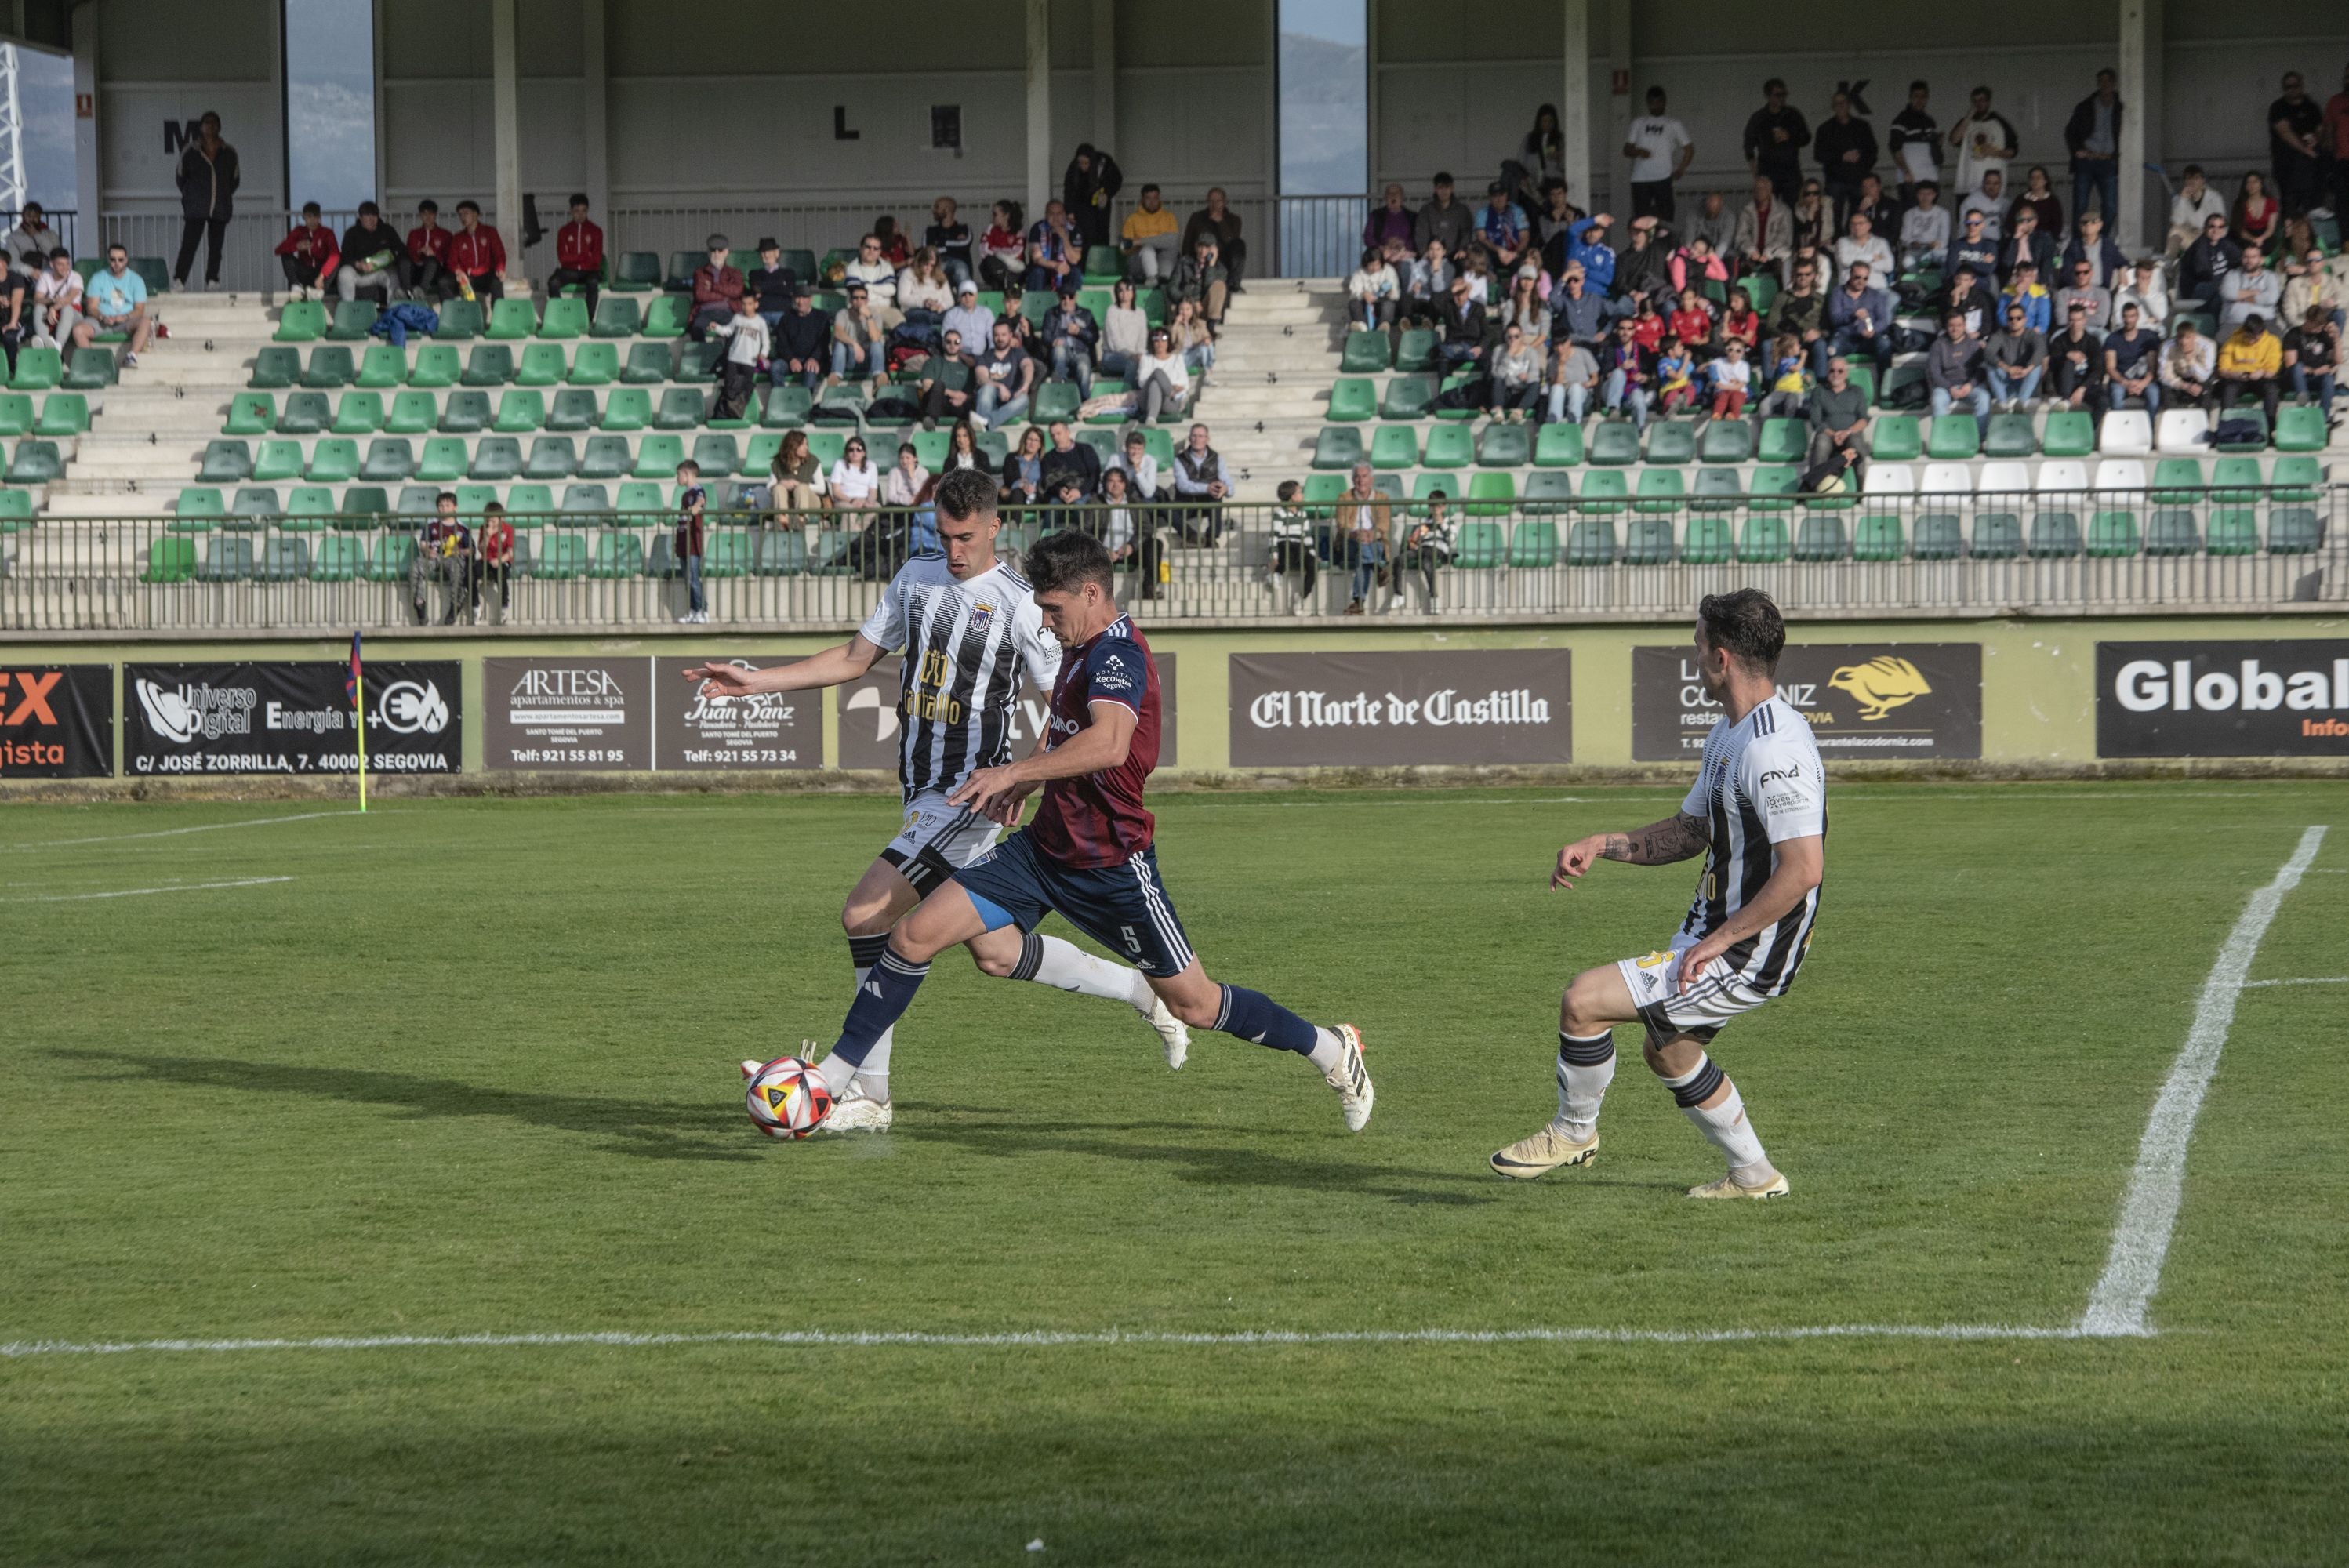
[0,1324,2083,1359]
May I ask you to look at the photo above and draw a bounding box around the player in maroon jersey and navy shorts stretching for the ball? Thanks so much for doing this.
[815,531,1374,1131]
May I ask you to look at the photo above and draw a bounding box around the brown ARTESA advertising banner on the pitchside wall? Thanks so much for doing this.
[481,657,652,772]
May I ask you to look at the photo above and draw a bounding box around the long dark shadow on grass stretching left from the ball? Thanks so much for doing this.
[49,1047,759,1160]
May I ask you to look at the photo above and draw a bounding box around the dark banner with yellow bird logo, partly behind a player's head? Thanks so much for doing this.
[1630,643,1983,763]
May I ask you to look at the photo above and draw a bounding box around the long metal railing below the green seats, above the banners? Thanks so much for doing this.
[0,490,2349,636]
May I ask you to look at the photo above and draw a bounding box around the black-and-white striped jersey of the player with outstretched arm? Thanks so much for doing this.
[862,552,1059,800]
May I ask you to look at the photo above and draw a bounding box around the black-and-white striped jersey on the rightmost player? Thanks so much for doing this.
[1679,697,1828,995]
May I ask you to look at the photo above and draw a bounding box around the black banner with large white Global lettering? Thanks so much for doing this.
[2095,638,2349,756]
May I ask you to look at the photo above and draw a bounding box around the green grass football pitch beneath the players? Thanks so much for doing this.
[0,782,2349,1568]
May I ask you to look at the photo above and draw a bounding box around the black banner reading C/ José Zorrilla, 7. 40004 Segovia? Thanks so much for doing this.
[122,659,465,775]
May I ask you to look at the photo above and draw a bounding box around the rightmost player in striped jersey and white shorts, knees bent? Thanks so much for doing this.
[1491,589,1828,1197]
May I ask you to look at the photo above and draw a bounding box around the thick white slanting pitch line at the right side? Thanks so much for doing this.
[2079,826,2325,1336]
